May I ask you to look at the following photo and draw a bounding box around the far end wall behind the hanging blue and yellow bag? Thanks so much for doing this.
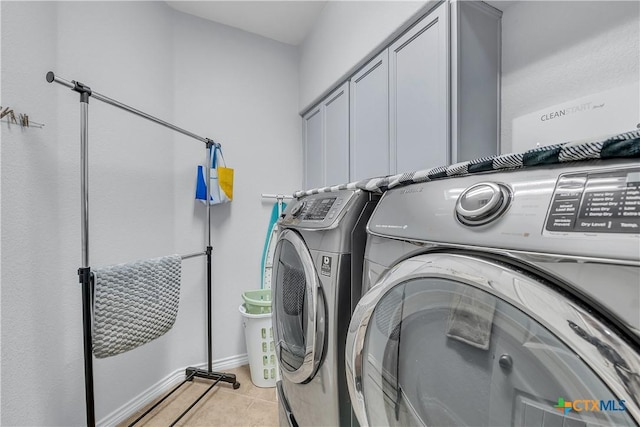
[172,7,302,372]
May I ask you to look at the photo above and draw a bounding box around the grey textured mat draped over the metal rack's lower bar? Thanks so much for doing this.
[93,255,182,359]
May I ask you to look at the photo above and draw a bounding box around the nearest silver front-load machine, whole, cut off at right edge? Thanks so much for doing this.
[345,160,640,427]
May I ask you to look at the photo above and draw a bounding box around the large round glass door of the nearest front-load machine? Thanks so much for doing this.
[346,254,640,427]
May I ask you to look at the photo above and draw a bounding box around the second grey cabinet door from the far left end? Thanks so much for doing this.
[322,82,349,185]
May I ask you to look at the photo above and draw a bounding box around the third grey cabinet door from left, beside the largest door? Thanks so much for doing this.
[349,50,389,181]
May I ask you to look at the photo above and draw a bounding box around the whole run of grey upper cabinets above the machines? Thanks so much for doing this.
[304,0,502,188]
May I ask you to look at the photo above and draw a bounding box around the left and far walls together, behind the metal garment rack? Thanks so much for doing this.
[0,1,301,426]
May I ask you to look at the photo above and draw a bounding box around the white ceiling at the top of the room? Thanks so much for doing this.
[166,0,326,46]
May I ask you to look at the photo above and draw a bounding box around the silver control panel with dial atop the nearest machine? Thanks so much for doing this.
[367,159,640,262]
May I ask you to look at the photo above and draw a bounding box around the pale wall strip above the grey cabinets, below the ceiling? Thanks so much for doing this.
[299,1,436,111]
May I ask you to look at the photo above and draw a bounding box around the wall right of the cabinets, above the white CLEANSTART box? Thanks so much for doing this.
[496,1,640,153]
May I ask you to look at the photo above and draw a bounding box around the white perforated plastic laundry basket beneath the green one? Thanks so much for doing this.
[238,304,280,387]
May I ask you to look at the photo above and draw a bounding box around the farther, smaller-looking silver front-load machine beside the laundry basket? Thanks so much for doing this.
[272,190,380,426]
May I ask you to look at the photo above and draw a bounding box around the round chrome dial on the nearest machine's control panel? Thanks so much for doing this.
[456,182,511,226]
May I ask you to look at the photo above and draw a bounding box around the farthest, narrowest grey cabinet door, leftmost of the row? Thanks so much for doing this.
[302,105,324,189]
